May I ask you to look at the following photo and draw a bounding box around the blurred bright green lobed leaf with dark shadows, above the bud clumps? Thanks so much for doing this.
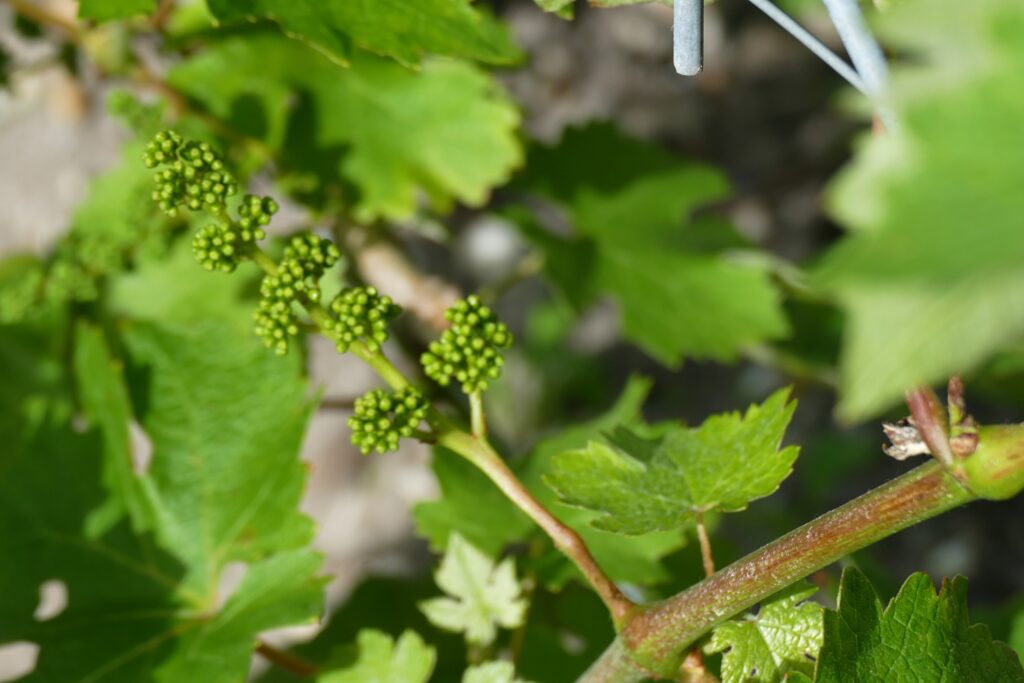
[170,34,522,222]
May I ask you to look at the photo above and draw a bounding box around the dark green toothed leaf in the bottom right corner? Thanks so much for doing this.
[814,568,1024,683]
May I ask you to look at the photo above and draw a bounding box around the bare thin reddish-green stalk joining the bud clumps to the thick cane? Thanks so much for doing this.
[437,428,636,629]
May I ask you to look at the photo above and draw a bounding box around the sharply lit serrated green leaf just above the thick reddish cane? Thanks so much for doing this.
[545,389,799,535]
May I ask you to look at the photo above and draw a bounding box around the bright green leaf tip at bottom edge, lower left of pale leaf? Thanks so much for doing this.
[316,629,437,683]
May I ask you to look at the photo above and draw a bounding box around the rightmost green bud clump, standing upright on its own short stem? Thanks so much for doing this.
[420,295,512,394]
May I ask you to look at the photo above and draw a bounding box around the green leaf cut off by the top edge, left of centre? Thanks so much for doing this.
[209,0,520,66]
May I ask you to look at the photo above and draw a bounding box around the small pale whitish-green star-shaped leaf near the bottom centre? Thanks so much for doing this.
[420,533,526,645]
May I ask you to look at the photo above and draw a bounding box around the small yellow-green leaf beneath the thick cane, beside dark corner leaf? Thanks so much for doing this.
[707,583,822,683]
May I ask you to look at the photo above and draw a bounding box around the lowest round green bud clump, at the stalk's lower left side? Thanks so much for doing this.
[348,387,430,455]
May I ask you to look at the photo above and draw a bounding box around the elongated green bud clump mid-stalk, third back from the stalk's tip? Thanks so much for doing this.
[255,232,341,354]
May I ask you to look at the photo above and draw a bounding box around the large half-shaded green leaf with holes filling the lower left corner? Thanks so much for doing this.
[0,326,324,683]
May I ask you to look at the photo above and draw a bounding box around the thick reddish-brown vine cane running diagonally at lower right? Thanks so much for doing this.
[580,462,976,683]
